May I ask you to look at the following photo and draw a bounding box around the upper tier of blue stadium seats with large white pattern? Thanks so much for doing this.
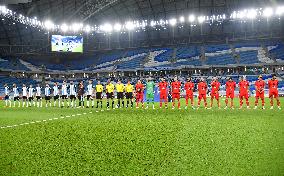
[0,41,284,71]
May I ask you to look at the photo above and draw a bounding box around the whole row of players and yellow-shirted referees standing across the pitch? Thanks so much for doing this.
[4,75,281,109]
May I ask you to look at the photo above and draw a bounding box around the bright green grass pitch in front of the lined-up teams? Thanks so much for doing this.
[0,98,284,175]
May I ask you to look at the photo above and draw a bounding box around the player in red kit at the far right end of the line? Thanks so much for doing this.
[268,74,281,109]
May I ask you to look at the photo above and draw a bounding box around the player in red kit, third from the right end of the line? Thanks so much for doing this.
[239,76,249,109]
